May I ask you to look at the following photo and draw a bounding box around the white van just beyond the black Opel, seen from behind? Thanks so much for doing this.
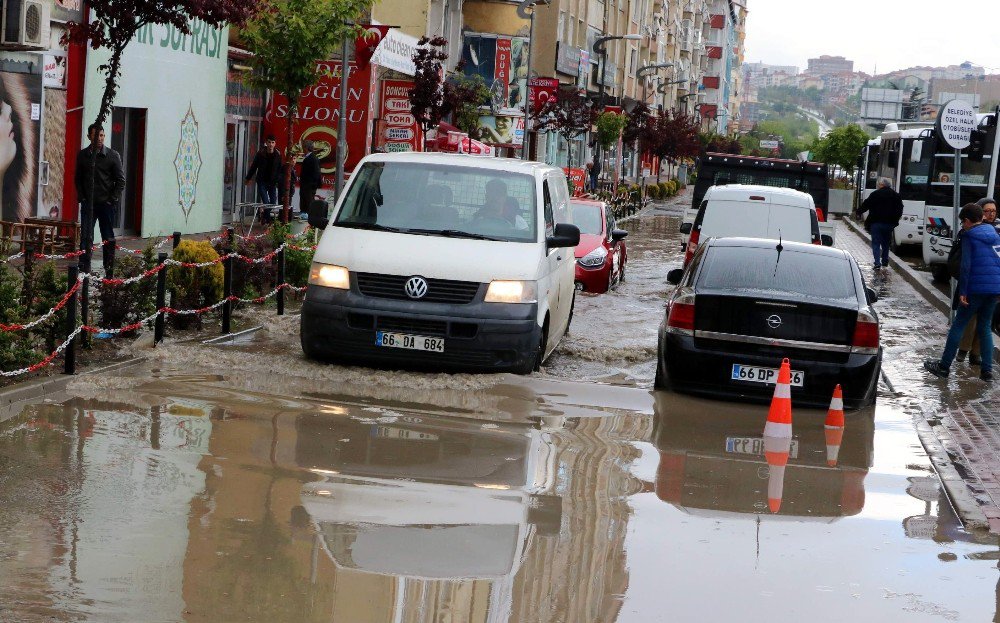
[681,184,833,266]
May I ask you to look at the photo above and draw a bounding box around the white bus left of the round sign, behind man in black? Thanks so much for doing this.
[875,123,934,252]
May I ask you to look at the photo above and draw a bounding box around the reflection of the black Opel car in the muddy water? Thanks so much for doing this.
[655,392,875,520]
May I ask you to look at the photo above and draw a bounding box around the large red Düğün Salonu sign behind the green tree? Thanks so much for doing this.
[264,61,374,188]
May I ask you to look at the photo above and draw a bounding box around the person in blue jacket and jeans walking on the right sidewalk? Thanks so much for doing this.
[924,203,1000,381]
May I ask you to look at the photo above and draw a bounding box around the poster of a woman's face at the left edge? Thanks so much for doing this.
[0,72,42,221]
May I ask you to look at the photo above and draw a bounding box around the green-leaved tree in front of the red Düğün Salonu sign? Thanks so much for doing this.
[241,0,371,222]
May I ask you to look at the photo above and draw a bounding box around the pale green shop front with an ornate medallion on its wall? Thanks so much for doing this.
[83,19,228,237]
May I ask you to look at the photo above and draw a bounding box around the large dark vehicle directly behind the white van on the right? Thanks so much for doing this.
[681,153,836,246]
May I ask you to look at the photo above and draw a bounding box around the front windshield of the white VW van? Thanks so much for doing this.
[334,162,538,242]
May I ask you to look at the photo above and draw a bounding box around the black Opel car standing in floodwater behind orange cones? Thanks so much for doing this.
[656,238,882,408]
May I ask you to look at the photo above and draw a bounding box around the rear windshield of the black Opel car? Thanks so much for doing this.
[698,247,857,301]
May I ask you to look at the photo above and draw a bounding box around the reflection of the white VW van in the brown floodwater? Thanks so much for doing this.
[296,415,561,584]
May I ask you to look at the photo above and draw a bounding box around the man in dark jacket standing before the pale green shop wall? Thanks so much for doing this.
[74,123,125,279]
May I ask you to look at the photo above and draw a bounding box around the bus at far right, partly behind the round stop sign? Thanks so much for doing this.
[923,110,1000,281]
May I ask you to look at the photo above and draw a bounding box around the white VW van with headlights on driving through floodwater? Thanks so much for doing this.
[301,153,580,374]
